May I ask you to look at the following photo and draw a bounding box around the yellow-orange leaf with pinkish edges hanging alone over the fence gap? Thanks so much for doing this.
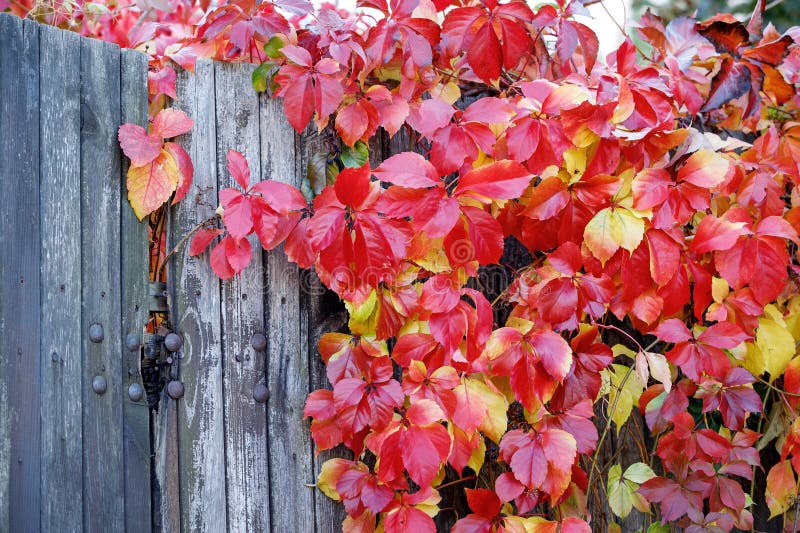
[127,149,180,220]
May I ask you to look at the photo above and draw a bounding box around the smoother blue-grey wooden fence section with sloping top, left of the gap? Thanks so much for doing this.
[0,10,150,532]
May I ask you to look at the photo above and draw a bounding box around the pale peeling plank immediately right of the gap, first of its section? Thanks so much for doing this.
[168,60,227,531]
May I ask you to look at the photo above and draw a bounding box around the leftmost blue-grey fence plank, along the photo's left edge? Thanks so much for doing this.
[0,15,41,532]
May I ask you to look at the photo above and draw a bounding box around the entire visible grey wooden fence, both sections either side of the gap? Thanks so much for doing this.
[0,14,354,532]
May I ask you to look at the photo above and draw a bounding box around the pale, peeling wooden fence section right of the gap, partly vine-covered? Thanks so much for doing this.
[155,60,352,532]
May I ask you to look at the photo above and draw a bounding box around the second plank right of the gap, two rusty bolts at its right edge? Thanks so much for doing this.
[216,64,272,531]
